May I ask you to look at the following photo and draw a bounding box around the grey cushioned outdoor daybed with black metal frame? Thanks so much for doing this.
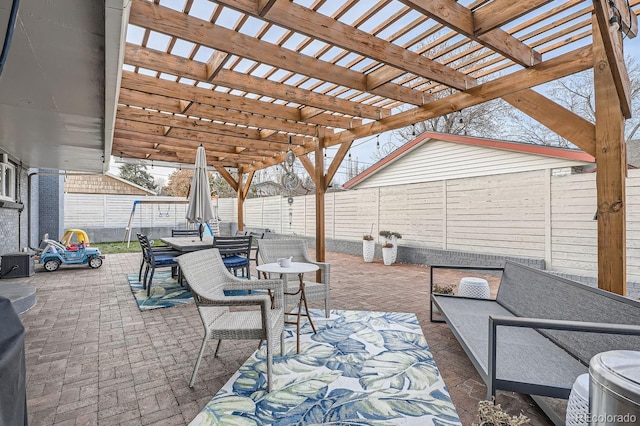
[431,261,640,424]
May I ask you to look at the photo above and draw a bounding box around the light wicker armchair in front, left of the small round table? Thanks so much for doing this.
[177,249,284,391]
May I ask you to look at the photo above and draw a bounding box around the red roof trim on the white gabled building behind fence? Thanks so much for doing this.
[344,132,595,188]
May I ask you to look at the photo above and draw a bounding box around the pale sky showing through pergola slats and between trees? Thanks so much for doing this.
[110,0,640,182]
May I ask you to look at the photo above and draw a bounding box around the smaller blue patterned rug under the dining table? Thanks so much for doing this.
[127,270,193,311]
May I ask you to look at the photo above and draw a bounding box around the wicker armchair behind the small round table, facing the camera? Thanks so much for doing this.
[258,238,331,318]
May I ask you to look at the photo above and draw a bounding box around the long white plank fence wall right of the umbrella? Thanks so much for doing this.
[219,170,640,281]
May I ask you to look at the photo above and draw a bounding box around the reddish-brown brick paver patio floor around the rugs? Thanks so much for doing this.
[12,252,549,425]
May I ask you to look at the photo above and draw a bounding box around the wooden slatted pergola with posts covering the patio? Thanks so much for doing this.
[111,0,640,294]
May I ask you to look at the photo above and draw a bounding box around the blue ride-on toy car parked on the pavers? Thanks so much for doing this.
[39,238,104,272]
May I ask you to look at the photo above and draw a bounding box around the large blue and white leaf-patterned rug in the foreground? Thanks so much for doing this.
[191,310,460,426]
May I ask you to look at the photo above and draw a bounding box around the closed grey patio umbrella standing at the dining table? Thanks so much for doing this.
[186,145,213,241]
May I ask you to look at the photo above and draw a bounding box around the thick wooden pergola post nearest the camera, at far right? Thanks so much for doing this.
[593,16,627,295]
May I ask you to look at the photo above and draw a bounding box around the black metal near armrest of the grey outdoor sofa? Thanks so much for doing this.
[487,315,640,399]
